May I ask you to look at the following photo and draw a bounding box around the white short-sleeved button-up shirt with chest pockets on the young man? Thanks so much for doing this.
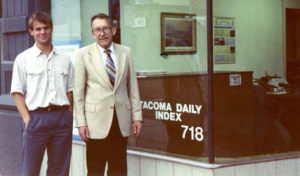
[10,45,74,110]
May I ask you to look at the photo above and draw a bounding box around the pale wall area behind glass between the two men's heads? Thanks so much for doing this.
[51,0,108,46]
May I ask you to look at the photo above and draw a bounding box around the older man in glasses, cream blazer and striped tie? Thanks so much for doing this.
[74,14,142,176]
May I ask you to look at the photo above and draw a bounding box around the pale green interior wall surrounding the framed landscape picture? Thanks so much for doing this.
[120,0,207,73]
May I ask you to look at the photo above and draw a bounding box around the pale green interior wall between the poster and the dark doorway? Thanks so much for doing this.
[213,0,285,78]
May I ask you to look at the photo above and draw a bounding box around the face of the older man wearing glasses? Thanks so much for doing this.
[92,18,116,49]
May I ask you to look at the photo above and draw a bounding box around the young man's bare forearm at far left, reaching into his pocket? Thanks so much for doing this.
[12,92,30,128]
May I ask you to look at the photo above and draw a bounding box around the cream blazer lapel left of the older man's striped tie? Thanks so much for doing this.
[89,43,113,89]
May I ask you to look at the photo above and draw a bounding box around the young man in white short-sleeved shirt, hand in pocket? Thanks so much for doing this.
[11,12,74,176]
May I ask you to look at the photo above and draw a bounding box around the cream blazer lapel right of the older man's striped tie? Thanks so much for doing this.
[114,44,126,88]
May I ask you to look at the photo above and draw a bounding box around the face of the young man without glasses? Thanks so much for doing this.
[29,21,53,45]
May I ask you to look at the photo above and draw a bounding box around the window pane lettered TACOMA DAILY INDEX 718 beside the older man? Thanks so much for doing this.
[120,0,207,160]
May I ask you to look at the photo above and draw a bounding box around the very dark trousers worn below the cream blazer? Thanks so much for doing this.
[86,111,127,176]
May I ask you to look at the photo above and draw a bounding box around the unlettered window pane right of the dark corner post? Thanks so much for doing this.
[213,0,300,161]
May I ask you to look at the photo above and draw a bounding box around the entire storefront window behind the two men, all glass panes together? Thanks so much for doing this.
[52,0,300,162]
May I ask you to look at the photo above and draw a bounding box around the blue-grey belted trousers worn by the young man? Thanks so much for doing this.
[21,109,73,176]
